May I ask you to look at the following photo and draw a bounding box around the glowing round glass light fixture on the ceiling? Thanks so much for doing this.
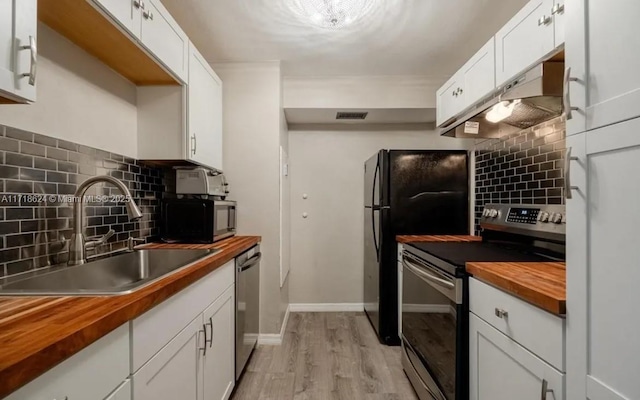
[293,0,374,29]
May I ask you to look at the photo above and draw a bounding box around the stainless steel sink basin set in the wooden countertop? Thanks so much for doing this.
[0,249,217,296]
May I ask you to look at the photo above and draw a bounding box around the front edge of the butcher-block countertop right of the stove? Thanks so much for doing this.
[466,263,567,316]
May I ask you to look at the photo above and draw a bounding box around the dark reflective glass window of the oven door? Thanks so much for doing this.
[402,260,458,400]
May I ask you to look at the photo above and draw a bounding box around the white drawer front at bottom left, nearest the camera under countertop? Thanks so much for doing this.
[5,324,129,400]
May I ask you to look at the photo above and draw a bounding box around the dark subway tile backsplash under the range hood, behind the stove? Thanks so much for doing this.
[475,117,566,233]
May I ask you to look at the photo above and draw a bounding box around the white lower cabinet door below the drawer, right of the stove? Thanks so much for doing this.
[469,313,564,400]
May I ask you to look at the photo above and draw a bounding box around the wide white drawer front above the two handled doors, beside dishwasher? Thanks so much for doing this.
[131,260,235,372]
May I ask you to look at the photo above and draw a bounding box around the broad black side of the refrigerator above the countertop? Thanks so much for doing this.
[389,151,469,235]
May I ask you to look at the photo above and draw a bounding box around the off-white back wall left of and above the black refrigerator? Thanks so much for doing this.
[289,130,473,303]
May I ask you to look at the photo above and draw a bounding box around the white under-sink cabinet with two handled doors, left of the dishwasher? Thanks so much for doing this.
[131,260,235,400]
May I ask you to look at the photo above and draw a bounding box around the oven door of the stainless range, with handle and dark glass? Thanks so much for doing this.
[402,252,464,400]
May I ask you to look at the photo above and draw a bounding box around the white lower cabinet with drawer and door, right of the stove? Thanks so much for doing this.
[469,278,566,400]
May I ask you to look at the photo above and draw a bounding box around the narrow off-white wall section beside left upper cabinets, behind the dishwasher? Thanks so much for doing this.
[213,63,289,334]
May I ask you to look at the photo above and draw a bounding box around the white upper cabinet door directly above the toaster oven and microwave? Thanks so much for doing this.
[187,44,222,170]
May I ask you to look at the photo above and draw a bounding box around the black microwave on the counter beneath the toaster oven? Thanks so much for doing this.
[160,198,236,243]
